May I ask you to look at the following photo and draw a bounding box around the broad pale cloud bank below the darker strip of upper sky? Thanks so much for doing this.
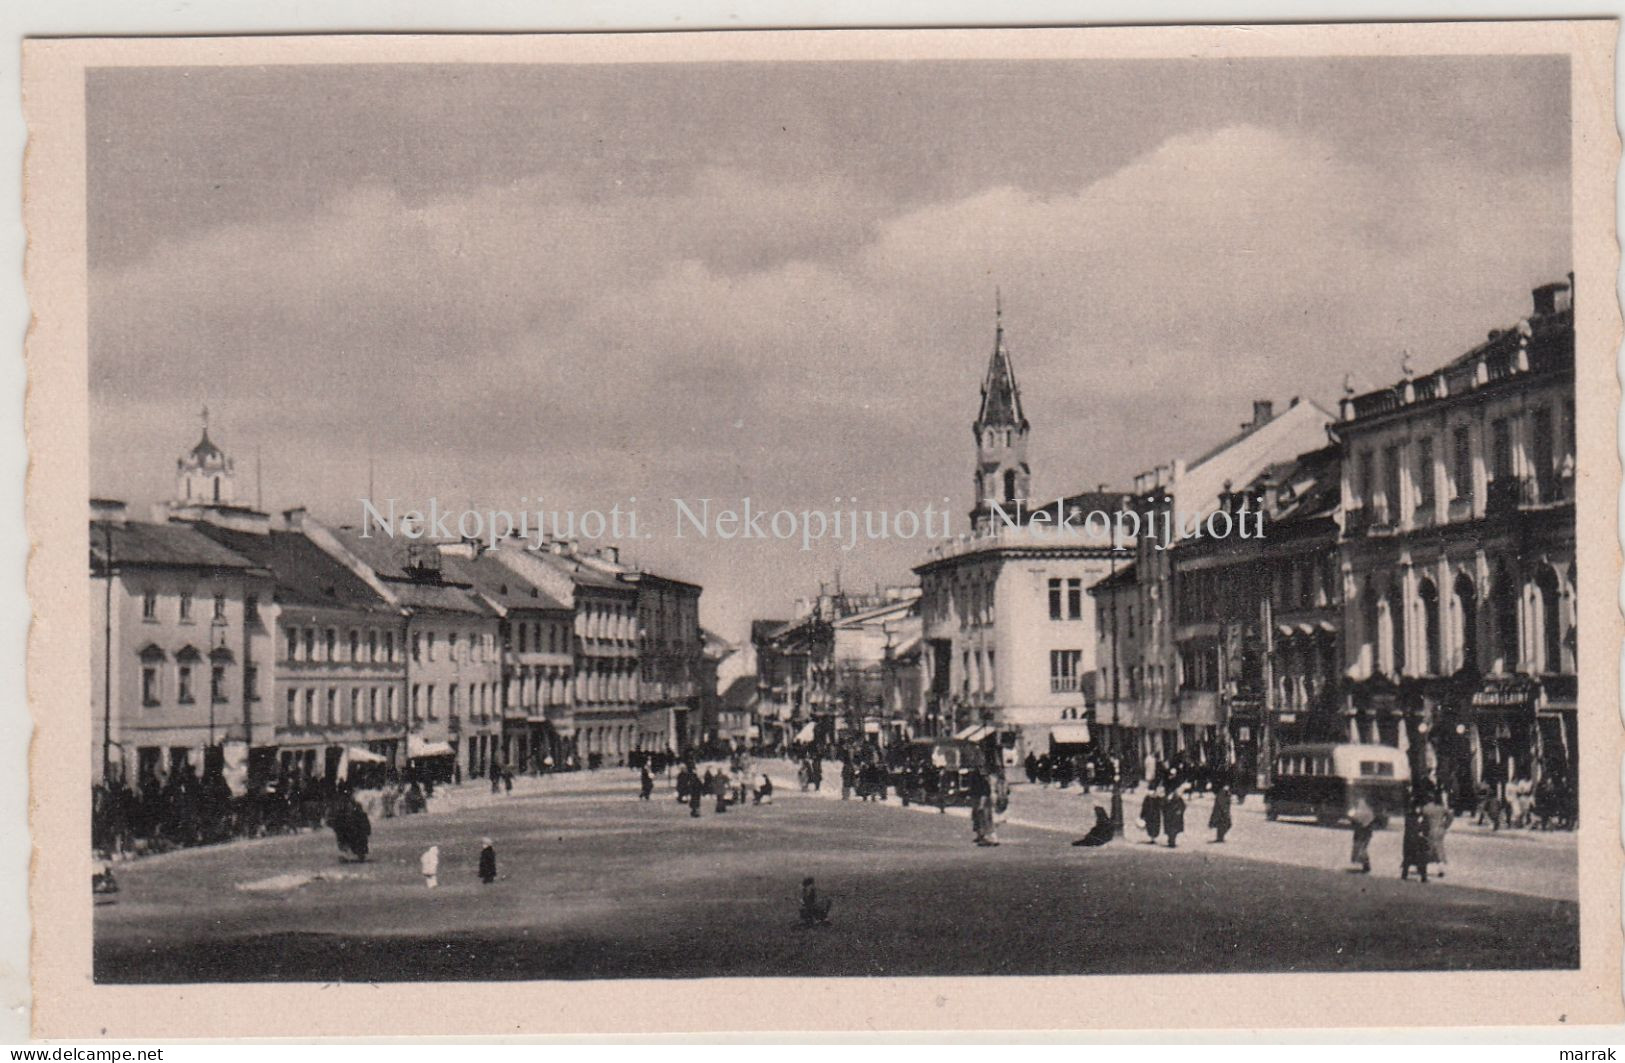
[91,124,1568,640]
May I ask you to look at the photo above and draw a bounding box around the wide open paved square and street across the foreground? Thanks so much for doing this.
[96,766,1578,982]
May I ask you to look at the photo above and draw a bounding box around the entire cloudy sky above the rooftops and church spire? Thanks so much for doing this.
[88,57,1570,637]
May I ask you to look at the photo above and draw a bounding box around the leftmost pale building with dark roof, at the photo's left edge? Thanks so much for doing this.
[89,501,276,792]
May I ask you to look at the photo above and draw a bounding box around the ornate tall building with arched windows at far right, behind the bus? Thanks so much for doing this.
[1337,278,1578,800]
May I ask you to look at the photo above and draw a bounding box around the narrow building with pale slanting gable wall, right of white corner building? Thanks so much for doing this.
[1090,398,1333,759]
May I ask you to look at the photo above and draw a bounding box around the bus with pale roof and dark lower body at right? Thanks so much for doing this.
[1264,743,1411,826]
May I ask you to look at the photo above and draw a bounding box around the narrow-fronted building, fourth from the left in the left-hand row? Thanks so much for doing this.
[440,543,575,772]
